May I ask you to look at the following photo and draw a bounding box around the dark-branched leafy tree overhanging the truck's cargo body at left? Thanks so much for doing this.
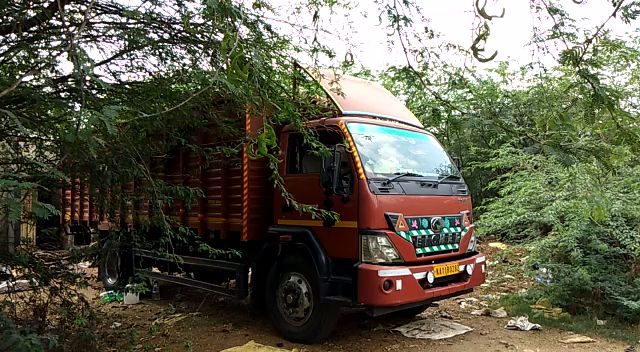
[0,0,330,349]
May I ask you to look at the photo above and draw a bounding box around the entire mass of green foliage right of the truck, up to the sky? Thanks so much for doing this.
[382,21,640,321]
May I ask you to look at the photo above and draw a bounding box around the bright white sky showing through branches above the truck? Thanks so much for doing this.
[264,0,637,70]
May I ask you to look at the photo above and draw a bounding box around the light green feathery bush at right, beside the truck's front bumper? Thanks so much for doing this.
[479,148,640,322]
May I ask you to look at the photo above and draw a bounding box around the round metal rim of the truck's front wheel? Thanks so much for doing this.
[276,272,313,326]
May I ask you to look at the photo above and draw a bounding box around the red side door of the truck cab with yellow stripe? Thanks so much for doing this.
[274,129,358,259]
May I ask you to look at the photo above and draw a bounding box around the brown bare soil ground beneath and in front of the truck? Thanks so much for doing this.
[92,248,628,352]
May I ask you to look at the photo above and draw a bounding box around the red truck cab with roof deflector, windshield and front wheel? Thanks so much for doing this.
[260,72,486,341]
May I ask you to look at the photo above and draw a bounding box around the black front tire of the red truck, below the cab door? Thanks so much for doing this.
[266,253,340,344]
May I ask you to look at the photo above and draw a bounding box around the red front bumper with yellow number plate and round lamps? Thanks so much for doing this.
[358,254,487,307]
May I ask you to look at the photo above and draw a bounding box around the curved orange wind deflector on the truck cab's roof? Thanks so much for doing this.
[307,70,423,128]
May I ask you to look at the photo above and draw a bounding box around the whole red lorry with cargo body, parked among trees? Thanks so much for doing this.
[61,72,486,343]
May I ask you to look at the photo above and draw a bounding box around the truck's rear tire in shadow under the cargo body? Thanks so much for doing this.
[100,242,131,291]
